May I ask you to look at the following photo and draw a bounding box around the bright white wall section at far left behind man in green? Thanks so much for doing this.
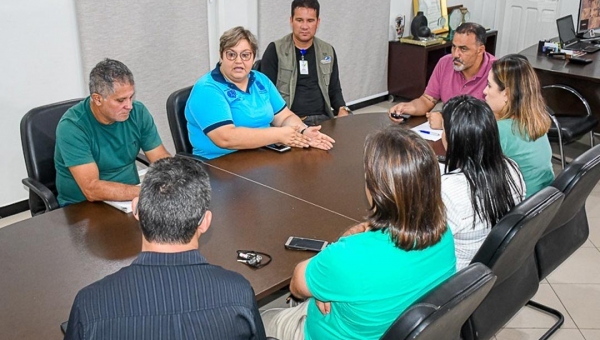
[0,0,86,207]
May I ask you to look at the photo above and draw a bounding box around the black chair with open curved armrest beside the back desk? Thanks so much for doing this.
[542,85,598,169]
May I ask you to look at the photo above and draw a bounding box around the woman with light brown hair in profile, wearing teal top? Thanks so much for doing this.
[483,54,554,197]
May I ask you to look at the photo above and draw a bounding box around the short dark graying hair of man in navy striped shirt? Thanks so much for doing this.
[138,157,211,244]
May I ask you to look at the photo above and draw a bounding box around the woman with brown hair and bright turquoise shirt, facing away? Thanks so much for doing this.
[262,126,456,339]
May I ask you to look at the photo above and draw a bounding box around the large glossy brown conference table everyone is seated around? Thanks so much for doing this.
[0,113,443,339]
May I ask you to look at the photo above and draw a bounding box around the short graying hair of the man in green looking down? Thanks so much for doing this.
[90,58,135,97]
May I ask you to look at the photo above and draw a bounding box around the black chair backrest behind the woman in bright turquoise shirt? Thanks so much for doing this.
[381,263,496,340]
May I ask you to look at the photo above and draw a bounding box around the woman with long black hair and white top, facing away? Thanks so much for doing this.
[442,95,525,270]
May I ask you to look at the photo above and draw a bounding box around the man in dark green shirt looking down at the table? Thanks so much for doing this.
[54,59,170,206]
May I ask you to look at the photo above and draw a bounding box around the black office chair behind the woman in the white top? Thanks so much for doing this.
[461,187,564,340]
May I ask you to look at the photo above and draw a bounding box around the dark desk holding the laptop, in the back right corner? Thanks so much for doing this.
[519,44,600,132]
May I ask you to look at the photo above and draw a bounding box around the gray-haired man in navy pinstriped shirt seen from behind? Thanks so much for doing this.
[65,157,265,340]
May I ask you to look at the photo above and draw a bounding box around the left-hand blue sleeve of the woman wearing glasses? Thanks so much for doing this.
[186,82,233,134]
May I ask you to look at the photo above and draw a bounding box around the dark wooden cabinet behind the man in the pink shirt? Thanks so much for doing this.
[388,31,498,99]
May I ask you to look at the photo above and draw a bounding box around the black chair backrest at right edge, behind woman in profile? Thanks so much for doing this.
[535,145,600,280]
